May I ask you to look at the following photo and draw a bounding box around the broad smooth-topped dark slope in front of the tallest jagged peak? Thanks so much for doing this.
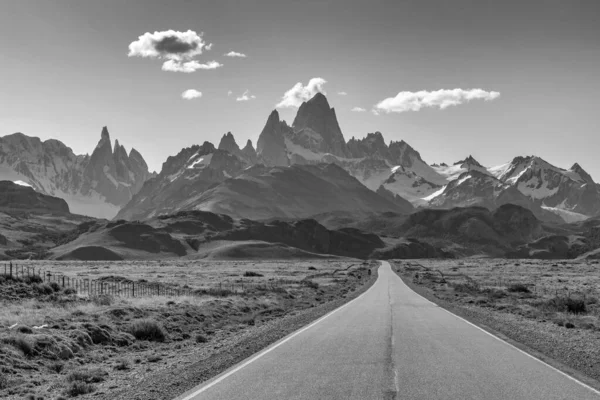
[117,159,413,220]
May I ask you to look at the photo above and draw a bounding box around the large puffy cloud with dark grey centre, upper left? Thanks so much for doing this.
[128,30,212,61]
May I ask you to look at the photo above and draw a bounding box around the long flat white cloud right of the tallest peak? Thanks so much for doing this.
[373,89,500,115]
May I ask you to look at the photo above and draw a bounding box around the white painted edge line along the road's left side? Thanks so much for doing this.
[175,263,383,400]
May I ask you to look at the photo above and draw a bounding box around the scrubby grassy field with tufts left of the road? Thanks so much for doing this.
[0,261,376,399]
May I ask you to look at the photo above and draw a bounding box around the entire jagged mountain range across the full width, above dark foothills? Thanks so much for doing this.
[0,93,600,223]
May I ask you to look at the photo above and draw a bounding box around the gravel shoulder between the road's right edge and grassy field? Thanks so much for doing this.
[392,262,600,390]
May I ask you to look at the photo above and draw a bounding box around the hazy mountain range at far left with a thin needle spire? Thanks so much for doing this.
[0,127,151,218]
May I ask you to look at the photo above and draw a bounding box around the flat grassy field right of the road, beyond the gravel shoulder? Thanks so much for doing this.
[398,260,600,329]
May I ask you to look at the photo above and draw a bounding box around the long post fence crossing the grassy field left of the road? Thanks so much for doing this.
[0,262,292,297]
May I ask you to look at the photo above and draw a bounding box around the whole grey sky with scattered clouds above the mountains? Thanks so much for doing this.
[0,0,600,177]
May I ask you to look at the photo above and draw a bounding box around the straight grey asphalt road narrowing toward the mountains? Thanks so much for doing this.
[178,262,600,400]
